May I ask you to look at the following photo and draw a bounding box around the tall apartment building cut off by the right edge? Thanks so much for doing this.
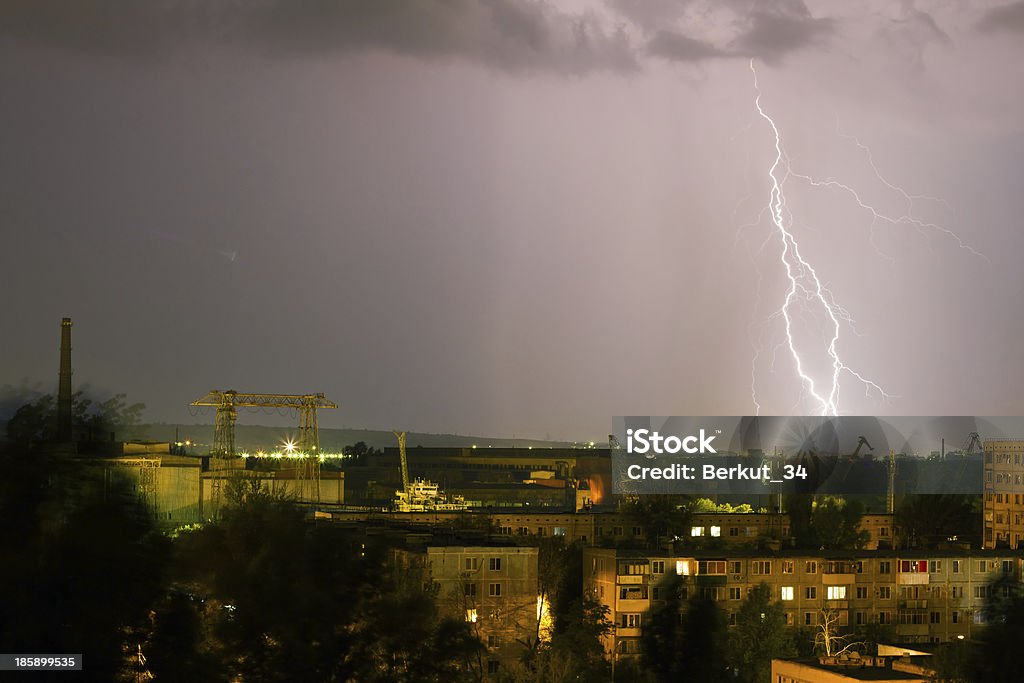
[982,439,1024,548]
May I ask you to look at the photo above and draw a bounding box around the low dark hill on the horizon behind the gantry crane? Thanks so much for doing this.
[139,423,572,453]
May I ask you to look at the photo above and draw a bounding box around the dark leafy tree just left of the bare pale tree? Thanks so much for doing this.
[729,584,796,683]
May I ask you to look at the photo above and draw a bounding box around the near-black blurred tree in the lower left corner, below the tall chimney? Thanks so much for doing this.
[0,450,169,681]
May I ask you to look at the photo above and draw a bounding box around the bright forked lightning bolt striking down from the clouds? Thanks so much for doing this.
[750,59,889,415]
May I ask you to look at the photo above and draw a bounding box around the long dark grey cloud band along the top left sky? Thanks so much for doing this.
[0,0,635,73]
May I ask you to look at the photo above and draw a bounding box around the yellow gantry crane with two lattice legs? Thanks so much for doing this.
[191,389,338,502]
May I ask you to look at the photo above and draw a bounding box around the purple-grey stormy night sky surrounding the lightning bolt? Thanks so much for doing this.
[0,0,1024,439]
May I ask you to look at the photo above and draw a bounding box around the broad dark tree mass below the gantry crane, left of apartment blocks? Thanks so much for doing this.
[171,479,482,683]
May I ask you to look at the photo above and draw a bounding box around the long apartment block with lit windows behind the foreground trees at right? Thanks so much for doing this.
[584,548,1021,656]
